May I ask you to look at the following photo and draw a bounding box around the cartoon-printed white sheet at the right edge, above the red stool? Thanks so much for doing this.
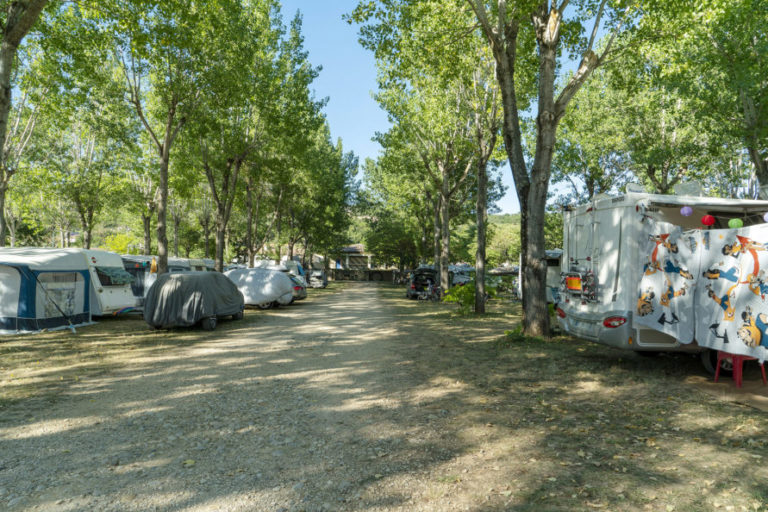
[696,224,768,361]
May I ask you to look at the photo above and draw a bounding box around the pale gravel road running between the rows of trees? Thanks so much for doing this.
[0,284,492,512]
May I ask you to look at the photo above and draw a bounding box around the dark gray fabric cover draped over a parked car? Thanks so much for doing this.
[144,272,243,327]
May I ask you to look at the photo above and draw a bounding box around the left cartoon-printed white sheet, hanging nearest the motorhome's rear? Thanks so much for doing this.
[633,217,698,343]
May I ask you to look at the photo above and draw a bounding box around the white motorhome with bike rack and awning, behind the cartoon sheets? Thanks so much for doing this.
[557,192,768,365]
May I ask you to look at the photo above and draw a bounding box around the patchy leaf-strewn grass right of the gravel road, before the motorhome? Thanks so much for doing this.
[381,288,768,511]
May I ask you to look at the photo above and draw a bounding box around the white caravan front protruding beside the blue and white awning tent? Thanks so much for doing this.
[82,249,139,316]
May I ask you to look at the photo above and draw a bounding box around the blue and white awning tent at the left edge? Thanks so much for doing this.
[0,248,91,334]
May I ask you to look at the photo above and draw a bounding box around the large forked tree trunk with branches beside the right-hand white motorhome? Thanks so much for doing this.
[466,0,627,336]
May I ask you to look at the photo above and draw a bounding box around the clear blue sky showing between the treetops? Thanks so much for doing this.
[281,0,520,213]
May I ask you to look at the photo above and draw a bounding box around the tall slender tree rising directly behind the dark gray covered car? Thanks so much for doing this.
[87,0,226,273]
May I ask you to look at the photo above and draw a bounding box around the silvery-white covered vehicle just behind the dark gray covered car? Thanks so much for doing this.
[224,268,293,309]
